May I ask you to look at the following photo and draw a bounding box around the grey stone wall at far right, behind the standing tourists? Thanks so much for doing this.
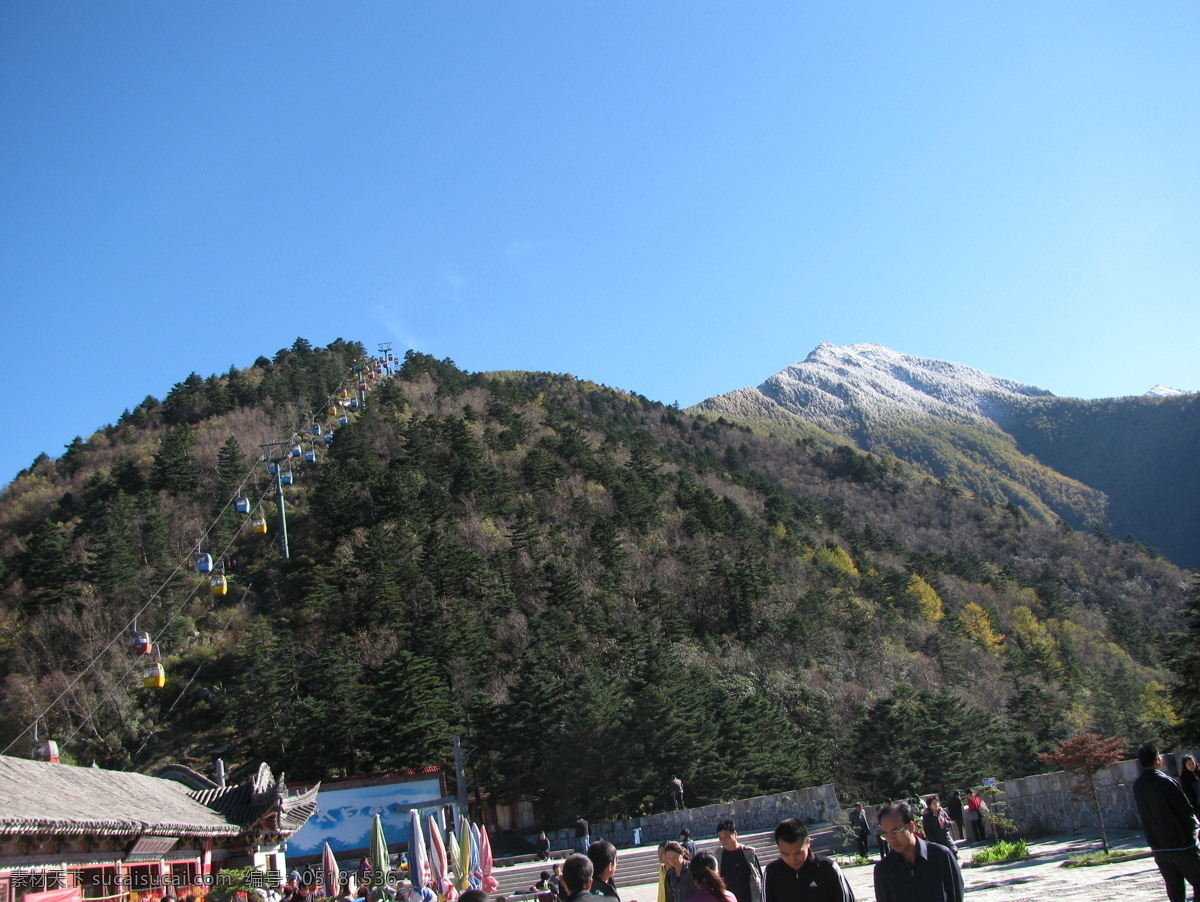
[1001,751,1200,836]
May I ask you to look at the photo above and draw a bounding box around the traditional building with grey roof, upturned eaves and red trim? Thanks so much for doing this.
[0,756,319,902]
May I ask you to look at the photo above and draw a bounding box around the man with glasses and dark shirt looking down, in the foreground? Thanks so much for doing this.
[868,802,964,902]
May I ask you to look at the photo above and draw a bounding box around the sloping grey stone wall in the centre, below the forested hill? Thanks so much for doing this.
[535,783,846,849]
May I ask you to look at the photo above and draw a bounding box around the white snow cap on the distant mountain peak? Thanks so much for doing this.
[758,342,1052,431]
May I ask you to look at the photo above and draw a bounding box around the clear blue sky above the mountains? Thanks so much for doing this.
[0,0,1200,482]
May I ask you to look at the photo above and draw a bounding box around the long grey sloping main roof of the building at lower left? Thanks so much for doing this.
[0,756,242,837]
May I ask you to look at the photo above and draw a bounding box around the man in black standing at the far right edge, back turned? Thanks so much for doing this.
[1133,742,1200,902]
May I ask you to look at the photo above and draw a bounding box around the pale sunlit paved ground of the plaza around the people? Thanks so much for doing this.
[497,830,1166,902]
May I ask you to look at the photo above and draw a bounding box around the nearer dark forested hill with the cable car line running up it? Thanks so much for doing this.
[0,341,1186,819]
